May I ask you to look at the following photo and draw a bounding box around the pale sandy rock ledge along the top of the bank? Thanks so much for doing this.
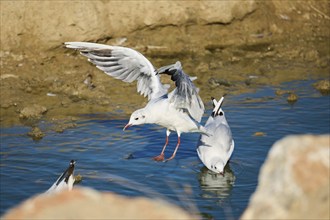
[0,0,256,50]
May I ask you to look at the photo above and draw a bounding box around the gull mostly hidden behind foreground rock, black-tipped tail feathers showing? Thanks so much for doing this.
[46,160,76,193]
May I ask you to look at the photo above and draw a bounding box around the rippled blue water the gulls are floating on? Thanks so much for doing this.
[0,81,330,219]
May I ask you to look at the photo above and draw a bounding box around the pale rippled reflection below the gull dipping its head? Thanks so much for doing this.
[199,163,236,203]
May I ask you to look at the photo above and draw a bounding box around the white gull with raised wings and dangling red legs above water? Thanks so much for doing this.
[65,42,206,161]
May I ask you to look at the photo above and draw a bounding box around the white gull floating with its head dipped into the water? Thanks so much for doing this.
[197,97,235,174]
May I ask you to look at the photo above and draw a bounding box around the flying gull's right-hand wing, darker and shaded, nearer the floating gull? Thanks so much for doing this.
[157,61,204,122]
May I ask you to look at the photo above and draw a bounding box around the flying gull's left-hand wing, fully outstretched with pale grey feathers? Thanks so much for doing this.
[65,42,167,100]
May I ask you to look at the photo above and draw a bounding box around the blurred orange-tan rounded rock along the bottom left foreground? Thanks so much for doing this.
[1,187,197,220]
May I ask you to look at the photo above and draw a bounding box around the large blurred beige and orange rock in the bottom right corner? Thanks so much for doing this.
[241,135,330,220]
